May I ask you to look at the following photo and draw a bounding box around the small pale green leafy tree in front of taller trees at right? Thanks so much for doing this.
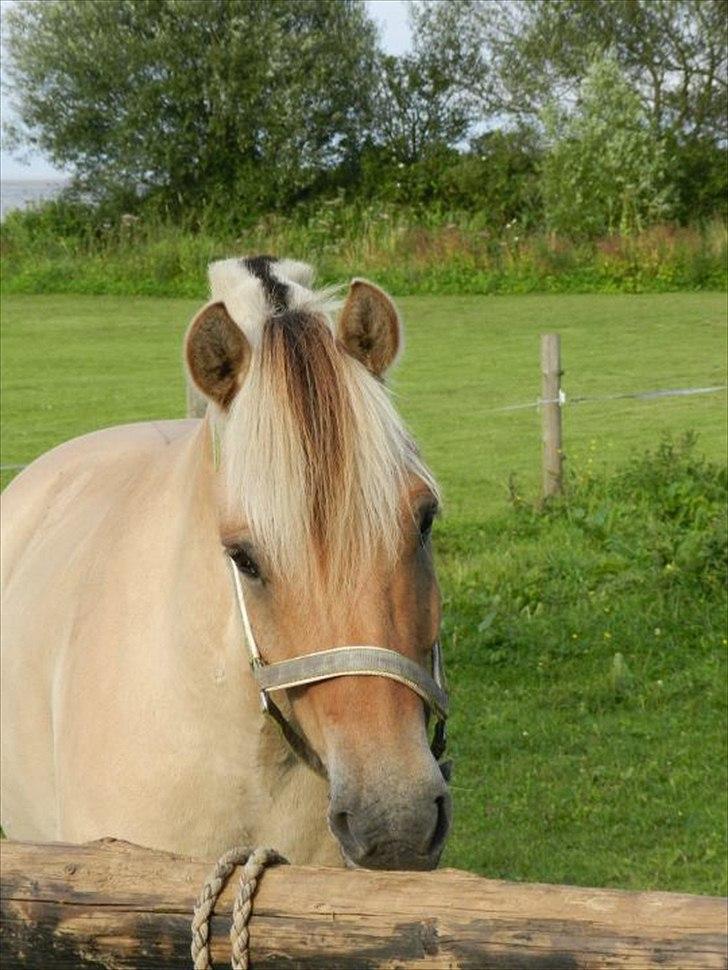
[542,57,669,236]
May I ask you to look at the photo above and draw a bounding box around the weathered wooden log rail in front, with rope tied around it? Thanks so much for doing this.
[0,840,727,970]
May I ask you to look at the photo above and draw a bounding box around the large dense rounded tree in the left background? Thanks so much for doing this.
[6,0,377,218]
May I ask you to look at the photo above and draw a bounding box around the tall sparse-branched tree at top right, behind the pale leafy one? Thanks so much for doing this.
[413,0,728,142]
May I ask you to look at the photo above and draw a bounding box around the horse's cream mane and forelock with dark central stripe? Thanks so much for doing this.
[213,257,438,589]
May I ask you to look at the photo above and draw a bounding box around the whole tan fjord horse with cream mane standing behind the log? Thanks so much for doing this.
[2,257,450,868]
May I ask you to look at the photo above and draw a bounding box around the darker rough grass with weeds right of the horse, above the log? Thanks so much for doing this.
[436,436,728,893]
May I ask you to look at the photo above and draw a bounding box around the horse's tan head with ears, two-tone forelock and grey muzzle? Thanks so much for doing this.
[185,257,451,869]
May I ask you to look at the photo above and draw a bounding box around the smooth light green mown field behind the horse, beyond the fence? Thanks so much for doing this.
[0,293,726,502]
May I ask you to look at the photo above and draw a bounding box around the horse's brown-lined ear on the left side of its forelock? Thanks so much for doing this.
[185,303,250,409]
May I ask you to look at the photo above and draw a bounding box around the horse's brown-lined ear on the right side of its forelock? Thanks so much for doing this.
[338,279,402,377]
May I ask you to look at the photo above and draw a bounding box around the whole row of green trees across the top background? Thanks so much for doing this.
[5,0,728,234]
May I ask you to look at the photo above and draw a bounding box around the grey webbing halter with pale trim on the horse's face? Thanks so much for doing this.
[228,558,450,779]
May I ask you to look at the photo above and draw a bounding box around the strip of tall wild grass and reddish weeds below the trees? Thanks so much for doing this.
[0,199,727,298]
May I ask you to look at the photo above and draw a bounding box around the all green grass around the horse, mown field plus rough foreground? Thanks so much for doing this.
[2,293,726,893]
